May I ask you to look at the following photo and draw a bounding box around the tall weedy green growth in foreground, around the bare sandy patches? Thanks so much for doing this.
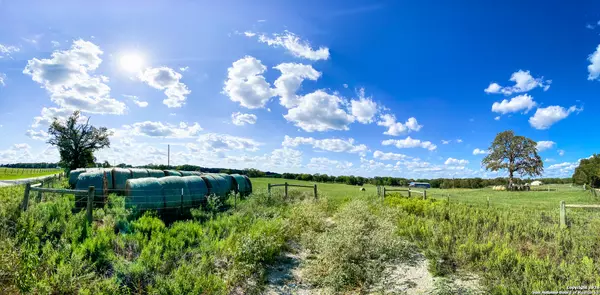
[0,179,600,294]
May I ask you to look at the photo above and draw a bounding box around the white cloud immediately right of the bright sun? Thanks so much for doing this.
[139,67,192,108]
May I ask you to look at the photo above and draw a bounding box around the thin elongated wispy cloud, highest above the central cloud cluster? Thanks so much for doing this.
[253,31,329,60]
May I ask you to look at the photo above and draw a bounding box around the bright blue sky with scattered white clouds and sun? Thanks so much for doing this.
[0,1,600,178]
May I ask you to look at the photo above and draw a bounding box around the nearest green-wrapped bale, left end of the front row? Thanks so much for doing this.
[125,177,165,210]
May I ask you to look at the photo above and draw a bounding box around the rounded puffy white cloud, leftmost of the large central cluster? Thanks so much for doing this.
[223,56,274,109]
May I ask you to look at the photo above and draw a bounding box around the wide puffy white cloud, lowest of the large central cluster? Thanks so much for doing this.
[283,90,354,132]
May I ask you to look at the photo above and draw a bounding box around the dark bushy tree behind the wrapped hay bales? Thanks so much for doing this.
[48,111,112,171]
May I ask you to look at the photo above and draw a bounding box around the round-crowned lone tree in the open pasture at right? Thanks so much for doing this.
[481,130,544,187]
